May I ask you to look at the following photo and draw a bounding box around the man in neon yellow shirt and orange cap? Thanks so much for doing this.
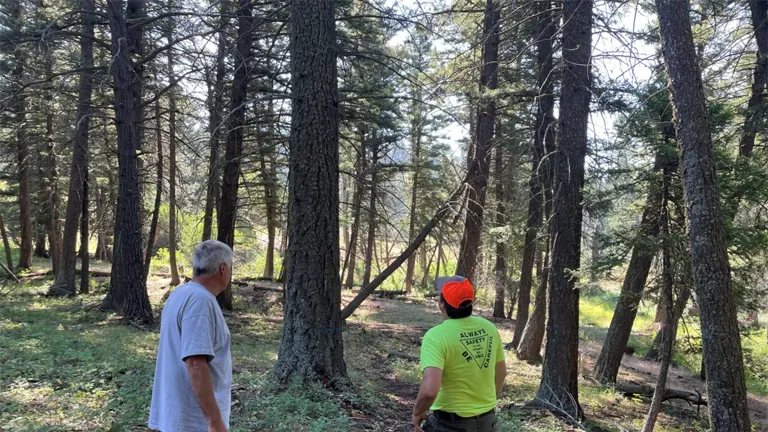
[412,276,507,432]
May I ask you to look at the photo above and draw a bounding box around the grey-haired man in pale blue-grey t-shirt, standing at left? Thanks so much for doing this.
[149,240,232,432]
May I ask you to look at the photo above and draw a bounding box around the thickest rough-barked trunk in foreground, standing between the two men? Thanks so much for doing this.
[274,0,347,385]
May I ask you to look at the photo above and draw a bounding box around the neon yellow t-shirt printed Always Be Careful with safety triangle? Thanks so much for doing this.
[421,315,504,417]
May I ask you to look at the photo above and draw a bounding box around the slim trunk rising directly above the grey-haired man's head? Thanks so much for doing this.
[203,0,229,241]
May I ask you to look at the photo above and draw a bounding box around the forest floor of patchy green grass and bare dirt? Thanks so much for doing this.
[0,268,768,431]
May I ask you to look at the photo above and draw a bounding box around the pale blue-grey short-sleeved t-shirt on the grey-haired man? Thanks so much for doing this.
[149,282,232,432]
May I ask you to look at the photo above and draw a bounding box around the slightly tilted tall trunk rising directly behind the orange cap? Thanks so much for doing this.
[456,0,500,280]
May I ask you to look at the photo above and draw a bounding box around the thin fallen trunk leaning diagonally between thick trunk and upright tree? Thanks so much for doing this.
[341,173,473,320]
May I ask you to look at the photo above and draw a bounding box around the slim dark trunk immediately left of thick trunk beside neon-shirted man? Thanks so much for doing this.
[512,1,556,344]
